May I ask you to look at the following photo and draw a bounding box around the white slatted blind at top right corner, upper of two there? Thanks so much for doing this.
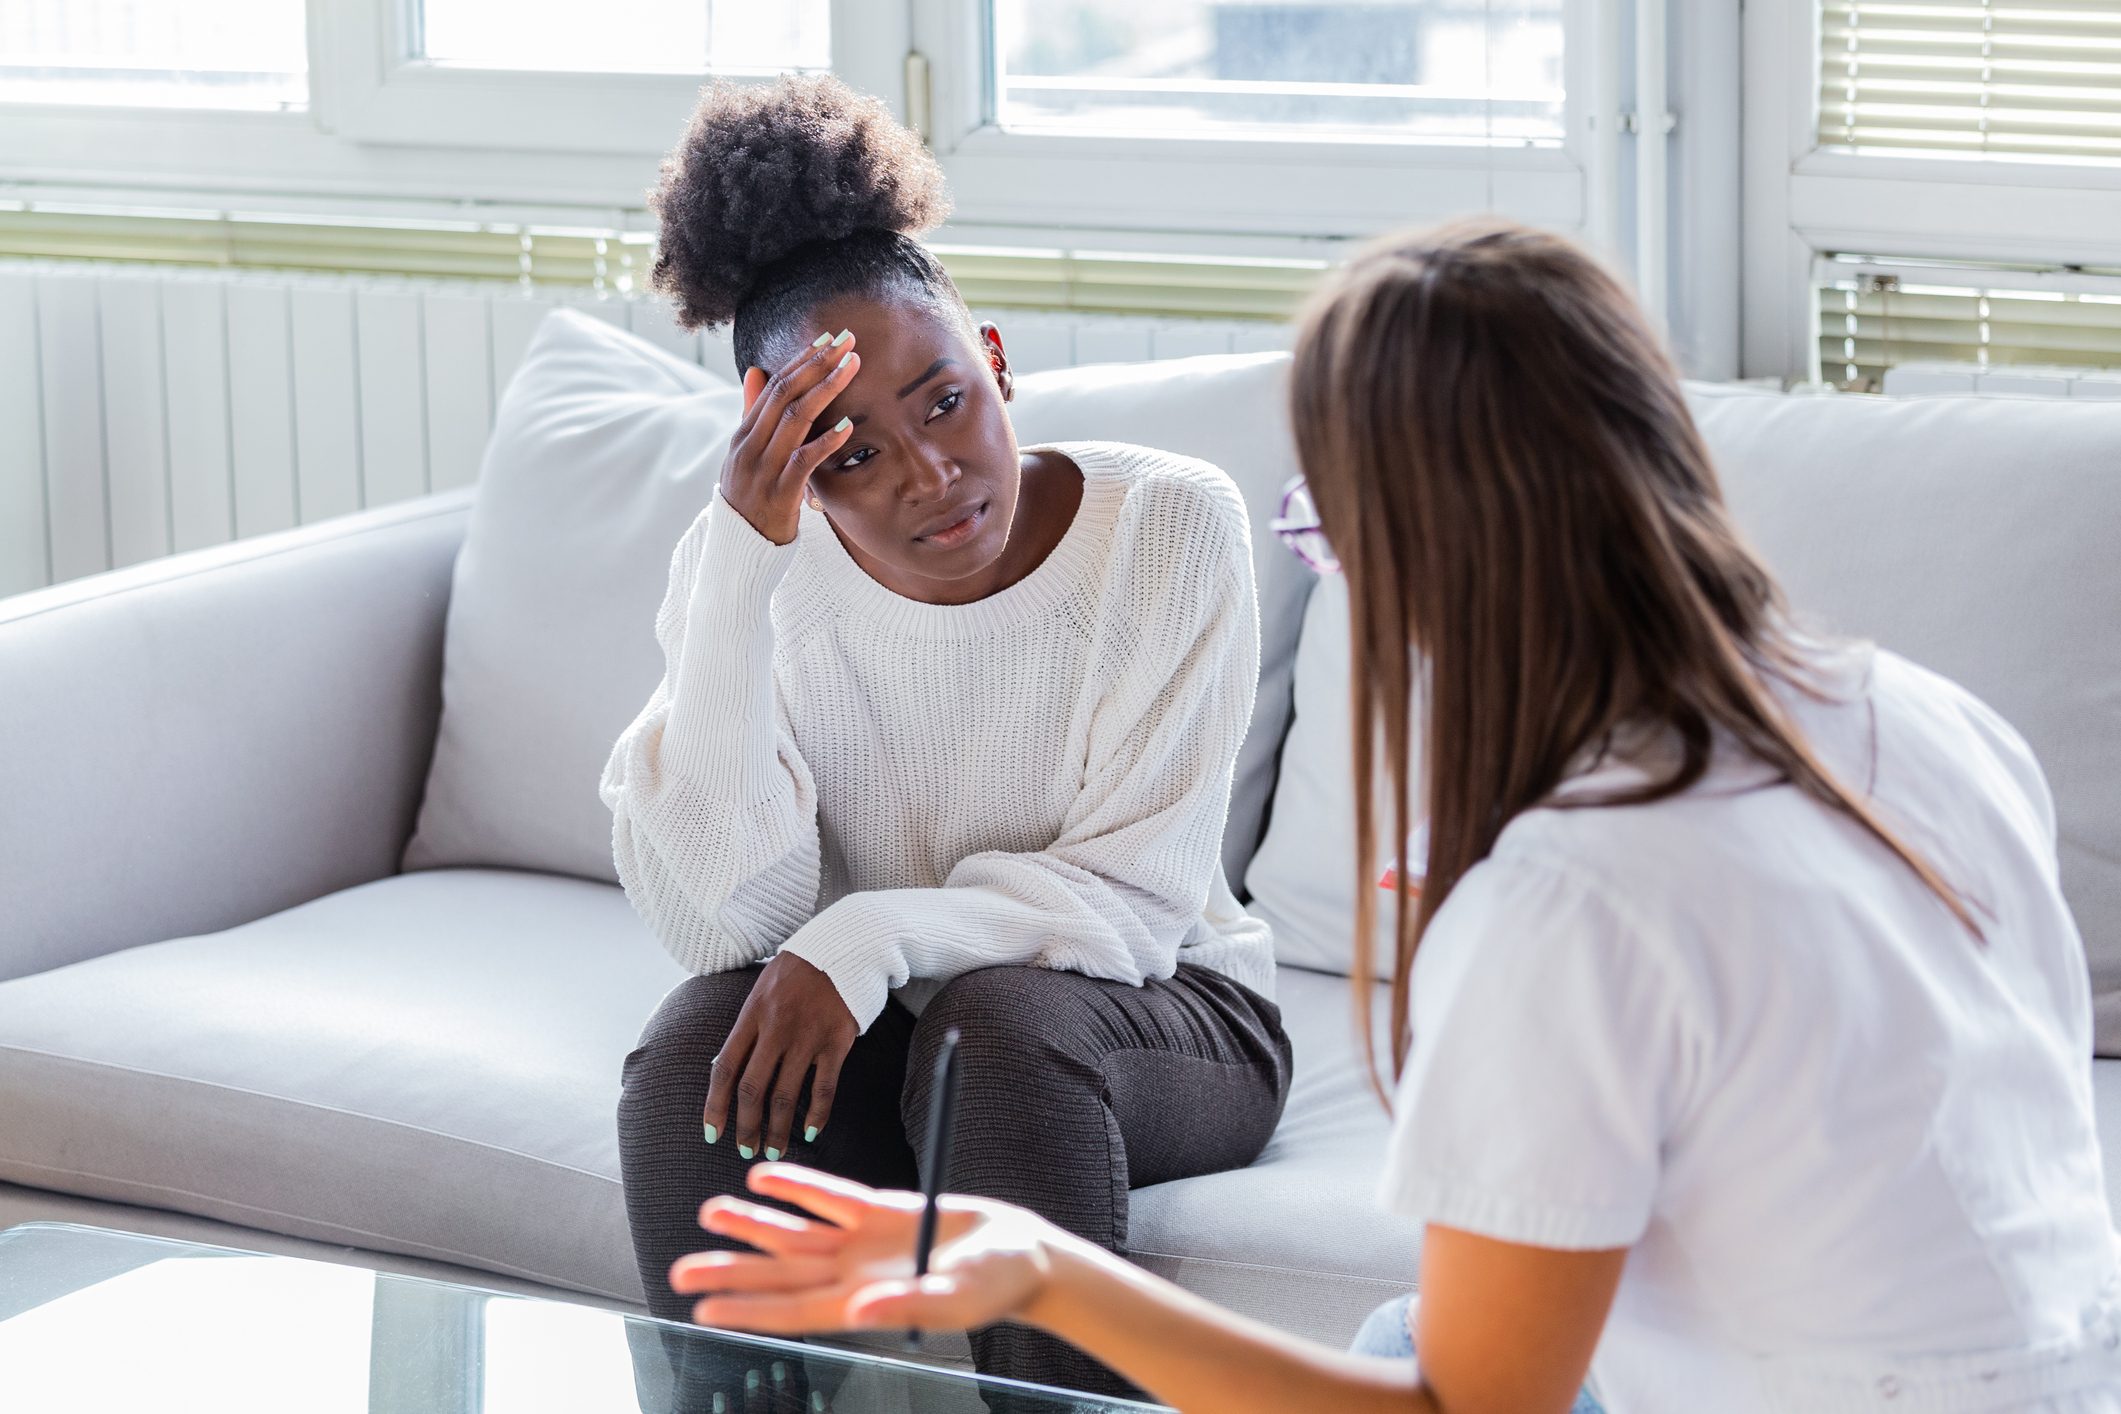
[1820,0,2121,161]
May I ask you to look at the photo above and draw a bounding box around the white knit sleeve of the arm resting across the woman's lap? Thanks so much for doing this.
[783,490,1260,1028]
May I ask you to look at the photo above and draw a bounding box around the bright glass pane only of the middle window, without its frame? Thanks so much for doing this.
[995,0,1565,146]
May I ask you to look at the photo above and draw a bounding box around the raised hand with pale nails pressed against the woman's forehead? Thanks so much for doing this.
[721,329,861,545]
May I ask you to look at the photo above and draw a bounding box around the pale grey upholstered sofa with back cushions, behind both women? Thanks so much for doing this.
[0,314,2121,1342]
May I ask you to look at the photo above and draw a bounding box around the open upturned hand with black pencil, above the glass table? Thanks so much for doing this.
[670,1164,1067,1336]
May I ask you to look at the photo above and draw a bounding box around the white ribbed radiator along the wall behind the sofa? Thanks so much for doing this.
[0,261,1287,596]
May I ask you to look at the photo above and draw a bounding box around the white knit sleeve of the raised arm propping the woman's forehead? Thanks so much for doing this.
[598,496,819,973]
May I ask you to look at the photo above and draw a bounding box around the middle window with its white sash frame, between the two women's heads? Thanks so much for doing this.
[910,0,1594,259]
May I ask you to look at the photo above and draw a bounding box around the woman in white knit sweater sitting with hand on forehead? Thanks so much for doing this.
[602,78,1290,1393]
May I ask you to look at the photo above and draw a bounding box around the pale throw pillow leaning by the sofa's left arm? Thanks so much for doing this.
[405,310,742,882]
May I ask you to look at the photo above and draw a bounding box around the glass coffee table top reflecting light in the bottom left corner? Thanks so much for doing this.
[0,1223,1158,1414]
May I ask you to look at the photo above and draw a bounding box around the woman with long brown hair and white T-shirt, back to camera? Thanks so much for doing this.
[653,223,2121,1414]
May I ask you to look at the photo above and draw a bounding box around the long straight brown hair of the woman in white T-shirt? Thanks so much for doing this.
[1290,220,1979,1083]
